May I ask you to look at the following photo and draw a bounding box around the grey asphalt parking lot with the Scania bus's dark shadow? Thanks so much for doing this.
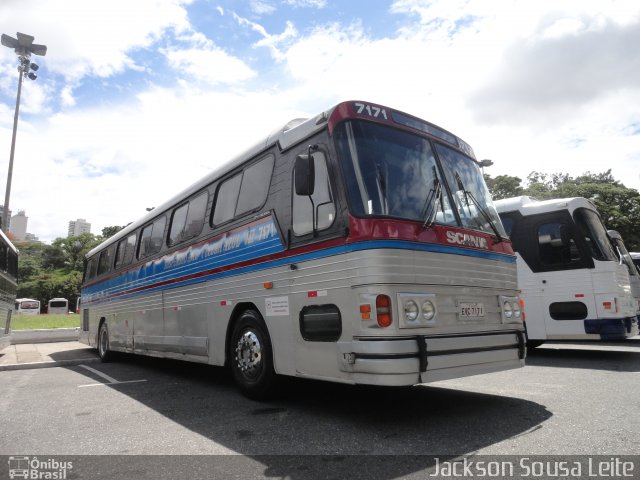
[0,341,640,478]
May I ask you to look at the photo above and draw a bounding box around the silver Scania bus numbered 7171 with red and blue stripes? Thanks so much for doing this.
[80,102,526,398]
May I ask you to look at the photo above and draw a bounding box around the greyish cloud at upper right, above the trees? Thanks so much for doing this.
[470,21,640,123]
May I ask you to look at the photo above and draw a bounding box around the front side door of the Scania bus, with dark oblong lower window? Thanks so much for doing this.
[288,145,346,376]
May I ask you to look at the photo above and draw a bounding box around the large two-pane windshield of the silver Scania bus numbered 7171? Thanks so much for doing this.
[336,121,506,237]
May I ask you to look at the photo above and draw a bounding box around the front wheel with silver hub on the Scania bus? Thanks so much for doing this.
[228,310,276,400]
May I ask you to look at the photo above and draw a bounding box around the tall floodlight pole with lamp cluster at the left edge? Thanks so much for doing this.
[0,32,47,231]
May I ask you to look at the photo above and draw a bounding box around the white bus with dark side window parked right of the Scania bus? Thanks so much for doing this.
[494,197,638,346]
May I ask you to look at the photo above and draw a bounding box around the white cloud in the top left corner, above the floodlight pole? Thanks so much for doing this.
[0,0,191,81]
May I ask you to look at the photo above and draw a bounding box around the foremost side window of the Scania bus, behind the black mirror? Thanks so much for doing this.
[292,151,336,236]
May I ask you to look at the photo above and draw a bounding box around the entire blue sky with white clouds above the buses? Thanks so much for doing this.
[0,0,640,241]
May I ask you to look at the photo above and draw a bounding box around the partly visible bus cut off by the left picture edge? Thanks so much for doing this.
[0,230,18,350]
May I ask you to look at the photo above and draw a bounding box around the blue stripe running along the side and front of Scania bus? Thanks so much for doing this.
[83,228,516,305]
